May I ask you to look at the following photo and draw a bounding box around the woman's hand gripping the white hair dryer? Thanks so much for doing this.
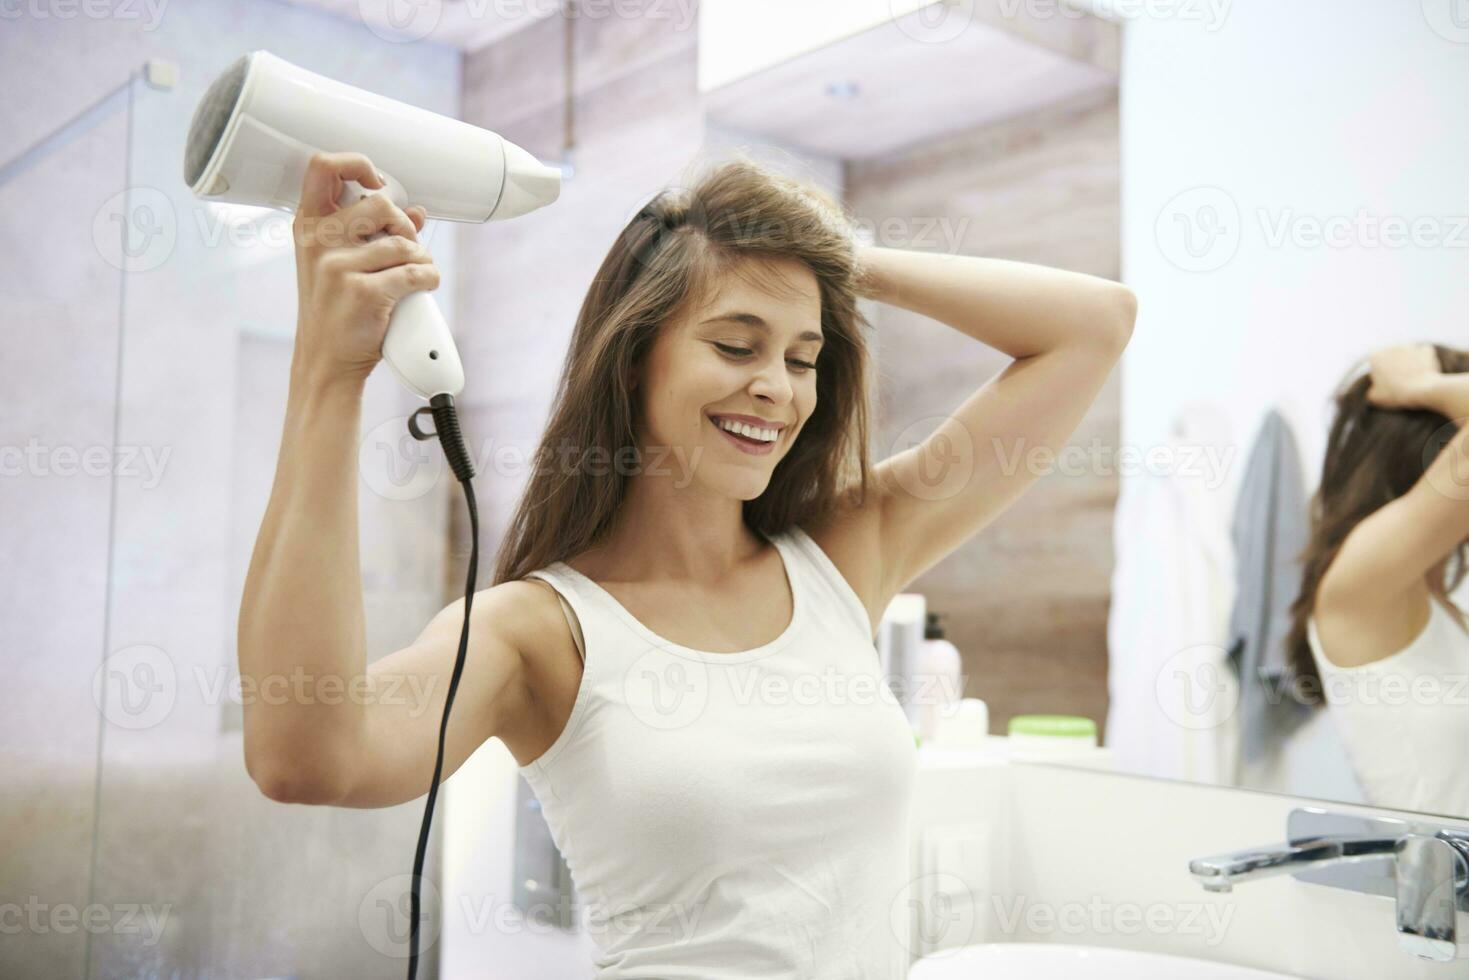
[292,153,439,381]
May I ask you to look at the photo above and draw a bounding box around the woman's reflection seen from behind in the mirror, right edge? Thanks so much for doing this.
[1287,344,1469,817]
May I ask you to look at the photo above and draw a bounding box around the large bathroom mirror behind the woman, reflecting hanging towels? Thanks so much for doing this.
[705,1,1469,817]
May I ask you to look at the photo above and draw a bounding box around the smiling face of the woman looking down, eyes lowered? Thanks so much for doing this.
[635,259,823,500]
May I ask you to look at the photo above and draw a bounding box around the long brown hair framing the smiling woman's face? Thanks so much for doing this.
[494,157,871,585]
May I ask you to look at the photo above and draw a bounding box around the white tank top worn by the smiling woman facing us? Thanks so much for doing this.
[519,527,918,980]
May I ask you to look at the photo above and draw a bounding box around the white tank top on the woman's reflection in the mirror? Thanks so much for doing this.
[1306,598,1469,817]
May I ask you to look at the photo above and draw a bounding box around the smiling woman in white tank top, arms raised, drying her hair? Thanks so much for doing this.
[239,154,1136,979]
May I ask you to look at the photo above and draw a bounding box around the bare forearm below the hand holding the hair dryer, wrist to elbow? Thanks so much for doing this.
[238,366,367,786]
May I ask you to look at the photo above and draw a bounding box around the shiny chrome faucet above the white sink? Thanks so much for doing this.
[1188,807,1469,962]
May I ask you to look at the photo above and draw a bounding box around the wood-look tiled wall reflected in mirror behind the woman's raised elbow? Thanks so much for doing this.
[846,93,1121,733]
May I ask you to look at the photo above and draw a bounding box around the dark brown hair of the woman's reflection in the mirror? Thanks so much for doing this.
[1285,344,1469,705]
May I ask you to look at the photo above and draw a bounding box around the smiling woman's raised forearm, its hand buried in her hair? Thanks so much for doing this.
[858,245,1137,359]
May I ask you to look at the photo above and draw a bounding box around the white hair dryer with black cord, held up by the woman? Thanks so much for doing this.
[184,50,561,400]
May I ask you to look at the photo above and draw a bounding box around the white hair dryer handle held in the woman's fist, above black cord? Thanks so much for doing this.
[336,173,464,400]
